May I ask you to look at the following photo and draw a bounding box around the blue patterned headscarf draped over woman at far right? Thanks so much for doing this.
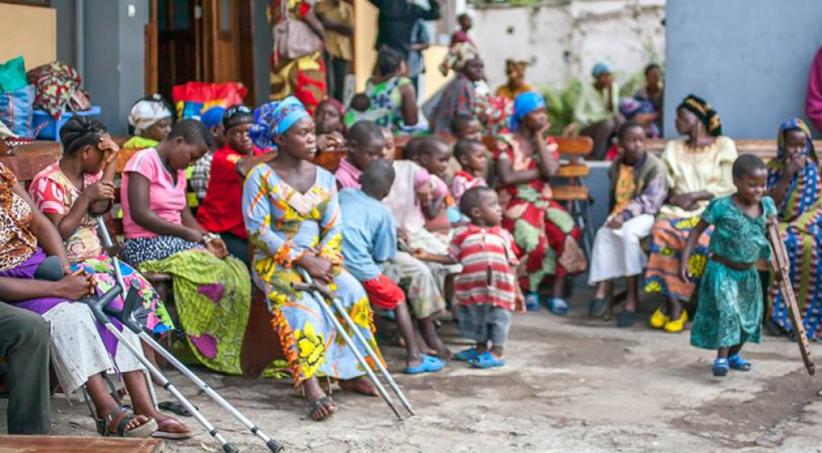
[768,118,822,222]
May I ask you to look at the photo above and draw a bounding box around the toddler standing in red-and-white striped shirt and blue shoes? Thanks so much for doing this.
[414,187,524,368]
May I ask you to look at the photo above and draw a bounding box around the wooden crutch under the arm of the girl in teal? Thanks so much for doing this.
[767,217,816,375]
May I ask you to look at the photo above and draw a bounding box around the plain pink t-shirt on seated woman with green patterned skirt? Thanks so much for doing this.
[120,148,186,239]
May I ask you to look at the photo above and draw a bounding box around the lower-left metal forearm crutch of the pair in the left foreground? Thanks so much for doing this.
[81,282,240,453]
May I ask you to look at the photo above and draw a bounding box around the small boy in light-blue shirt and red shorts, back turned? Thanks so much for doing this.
[339,160,445,374]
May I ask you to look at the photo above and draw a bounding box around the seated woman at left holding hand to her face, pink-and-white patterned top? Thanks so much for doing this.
[29,116,174,334]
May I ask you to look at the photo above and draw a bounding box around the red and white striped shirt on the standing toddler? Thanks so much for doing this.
[448,225,519,310]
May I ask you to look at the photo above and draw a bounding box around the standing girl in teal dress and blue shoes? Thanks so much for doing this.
[679,154,776,377]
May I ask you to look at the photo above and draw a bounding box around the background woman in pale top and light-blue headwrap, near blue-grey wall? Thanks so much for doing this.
[565,61,623,159]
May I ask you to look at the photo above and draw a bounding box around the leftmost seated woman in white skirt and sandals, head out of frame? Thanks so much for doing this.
[0,164,191,438]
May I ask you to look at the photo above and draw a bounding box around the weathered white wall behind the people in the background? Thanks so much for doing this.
[470,0,665,88]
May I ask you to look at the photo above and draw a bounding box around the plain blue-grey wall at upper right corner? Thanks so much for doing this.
[665,0,822,139]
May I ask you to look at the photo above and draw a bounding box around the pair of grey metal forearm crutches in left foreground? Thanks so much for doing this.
[91,217,283,453]
